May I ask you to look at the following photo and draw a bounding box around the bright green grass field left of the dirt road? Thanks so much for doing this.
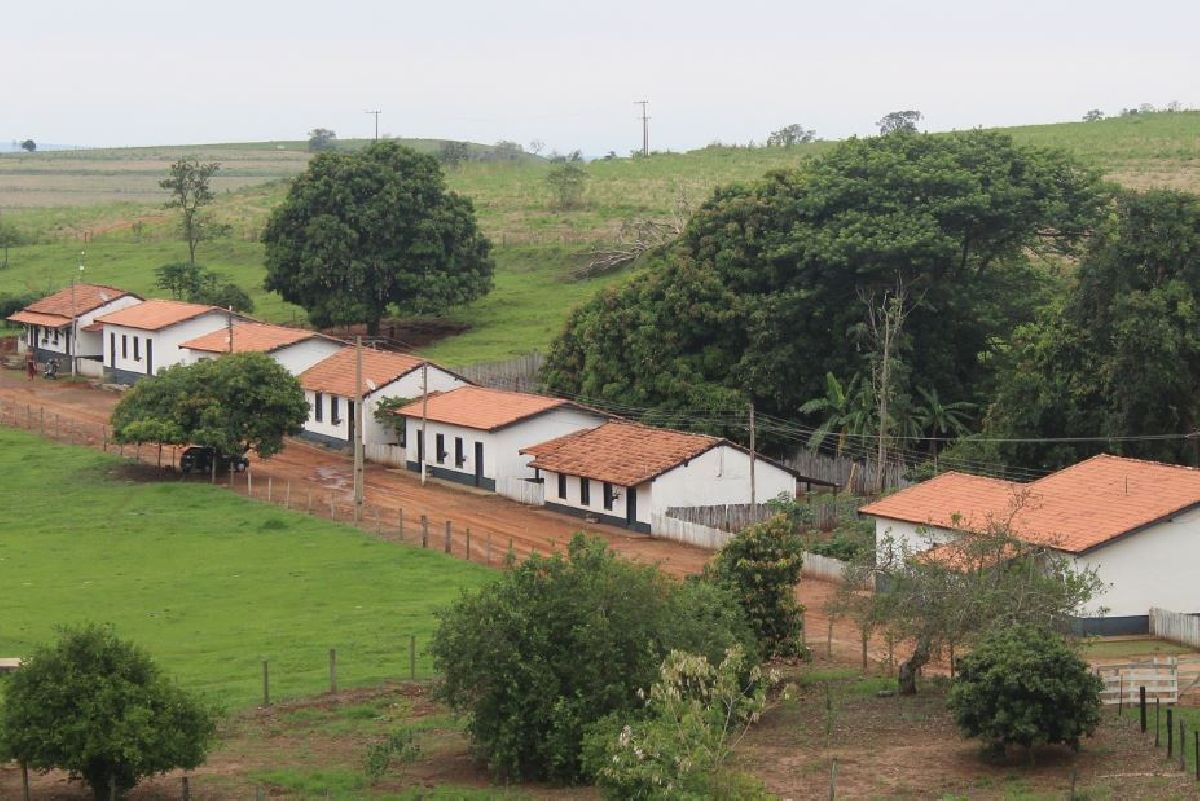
[0,428,494,709]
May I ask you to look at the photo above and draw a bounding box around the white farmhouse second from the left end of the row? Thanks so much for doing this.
[96,299,242,384]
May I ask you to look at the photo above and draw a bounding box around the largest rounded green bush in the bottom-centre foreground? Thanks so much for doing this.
[431,535,755,782]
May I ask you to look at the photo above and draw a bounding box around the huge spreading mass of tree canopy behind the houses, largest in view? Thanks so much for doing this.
[545,131,1100,448]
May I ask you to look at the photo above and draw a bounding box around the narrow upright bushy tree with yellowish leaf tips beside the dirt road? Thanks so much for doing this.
[704,514,804,656]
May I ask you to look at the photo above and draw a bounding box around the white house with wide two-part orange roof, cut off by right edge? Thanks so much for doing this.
[859,456,1200,634]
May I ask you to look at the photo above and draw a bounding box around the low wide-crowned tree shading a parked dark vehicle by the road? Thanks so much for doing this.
[113,353,308,457]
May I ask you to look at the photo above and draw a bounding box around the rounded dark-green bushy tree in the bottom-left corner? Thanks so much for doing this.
[0,625,216,800]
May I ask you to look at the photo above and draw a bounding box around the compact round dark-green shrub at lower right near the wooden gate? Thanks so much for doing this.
[949,626,1103,758]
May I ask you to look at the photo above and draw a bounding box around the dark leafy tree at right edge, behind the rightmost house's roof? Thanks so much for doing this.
[988,191,1200,469]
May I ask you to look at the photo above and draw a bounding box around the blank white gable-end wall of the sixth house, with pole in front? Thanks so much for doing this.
[640,445,796,514]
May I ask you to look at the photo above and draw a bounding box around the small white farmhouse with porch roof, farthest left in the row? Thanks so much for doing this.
[8,284,142,375]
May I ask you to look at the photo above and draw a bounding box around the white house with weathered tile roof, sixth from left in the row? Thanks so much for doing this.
[522,421,803,534]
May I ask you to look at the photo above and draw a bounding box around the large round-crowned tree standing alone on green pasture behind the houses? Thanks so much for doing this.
[263,141,493,333]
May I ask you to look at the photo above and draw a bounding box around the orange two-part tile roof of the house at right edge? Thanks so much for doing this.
[859,456,1200,553]
